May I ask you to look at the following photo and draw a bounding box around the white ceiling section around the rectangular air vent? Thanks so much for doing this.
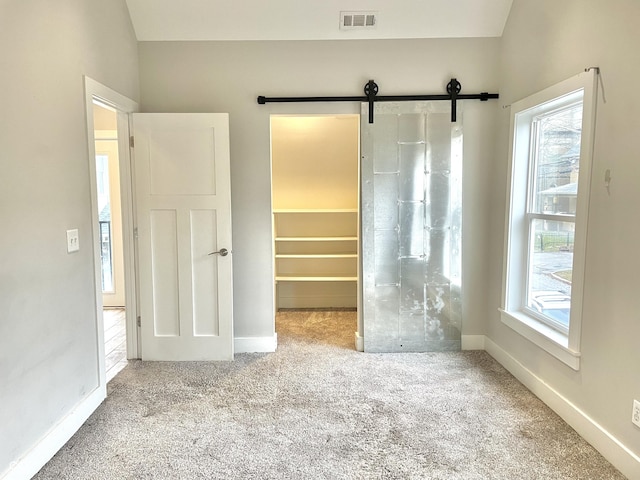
[126,0,512,41]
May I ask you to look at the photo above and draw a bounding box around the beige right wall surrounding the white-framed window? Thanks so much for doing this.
[488,0,640,472]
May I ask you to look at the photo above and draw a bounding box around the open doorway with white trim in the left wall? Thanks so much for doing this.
[85,77,139,386]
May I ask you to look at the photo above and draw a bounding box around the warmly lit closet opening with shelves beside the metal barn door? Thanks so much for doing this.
[271,115,360,346]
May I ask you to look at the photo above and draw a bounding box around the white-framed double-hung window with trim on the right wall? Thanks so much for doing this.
[501,71,596,370]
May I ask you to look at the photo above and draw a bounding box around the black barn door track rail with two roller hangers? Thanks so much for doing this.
[258,78,499,123]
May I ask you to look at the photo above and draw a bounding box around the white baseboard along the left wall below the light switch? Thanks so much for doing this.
[0,386,107,480]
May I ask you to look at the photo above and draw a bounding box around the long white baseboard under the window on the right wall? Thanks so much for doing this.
[485,338,640,478]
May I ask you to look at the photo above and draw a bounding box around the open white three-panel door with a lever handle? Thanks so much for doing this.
[133,113,233,360]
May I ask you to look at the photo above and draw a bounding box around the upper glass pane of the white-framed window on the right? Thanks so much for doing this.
[532,103,582,215]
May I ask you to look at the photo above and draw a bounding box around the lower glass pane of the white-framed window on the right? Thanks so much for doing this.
[526,219,575,331]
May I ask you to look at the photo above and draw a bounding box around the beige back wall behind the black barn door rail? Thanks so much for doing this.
[139,39,499,337]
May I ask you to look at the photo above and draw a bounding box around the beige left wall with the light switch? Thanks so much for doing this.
[0,0,138,476]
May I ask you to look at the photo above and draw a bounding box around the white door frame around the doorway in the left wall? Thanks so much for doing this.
[84,76,140,388]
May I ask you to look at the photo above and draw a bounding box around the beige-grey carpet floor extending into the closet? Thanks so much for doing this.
[34,311,624,480]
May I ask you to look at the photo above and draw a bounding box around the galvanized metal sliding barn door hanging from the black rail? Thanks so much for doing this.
[361,102,462,352]
